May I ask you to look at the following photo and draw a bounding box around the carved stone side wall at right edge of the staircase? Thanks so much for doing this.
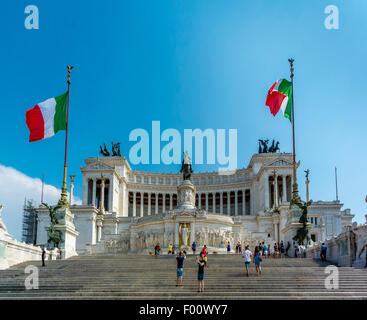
[306,219,367,268]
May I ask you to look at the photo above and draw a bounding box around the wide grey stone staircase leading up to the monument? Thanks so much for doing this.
[0,254,367,300]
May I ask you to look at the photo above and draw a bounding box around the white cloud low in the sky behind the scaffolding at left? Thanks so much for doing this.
[0,164,81,240]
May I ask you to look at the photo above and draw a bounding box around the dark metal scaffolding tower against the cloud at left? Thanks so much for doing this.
[22,199,37,245]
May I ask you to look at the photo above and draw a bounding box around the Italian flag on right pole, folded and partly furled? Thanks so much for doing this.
[265,79,292,122]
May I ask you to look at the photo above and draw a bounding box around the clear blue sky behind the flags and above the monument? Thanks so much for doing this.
[0,0,367,240]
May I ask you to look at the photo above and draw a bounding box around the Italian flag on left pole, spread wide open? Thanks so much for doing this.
[25,92,68,142]
